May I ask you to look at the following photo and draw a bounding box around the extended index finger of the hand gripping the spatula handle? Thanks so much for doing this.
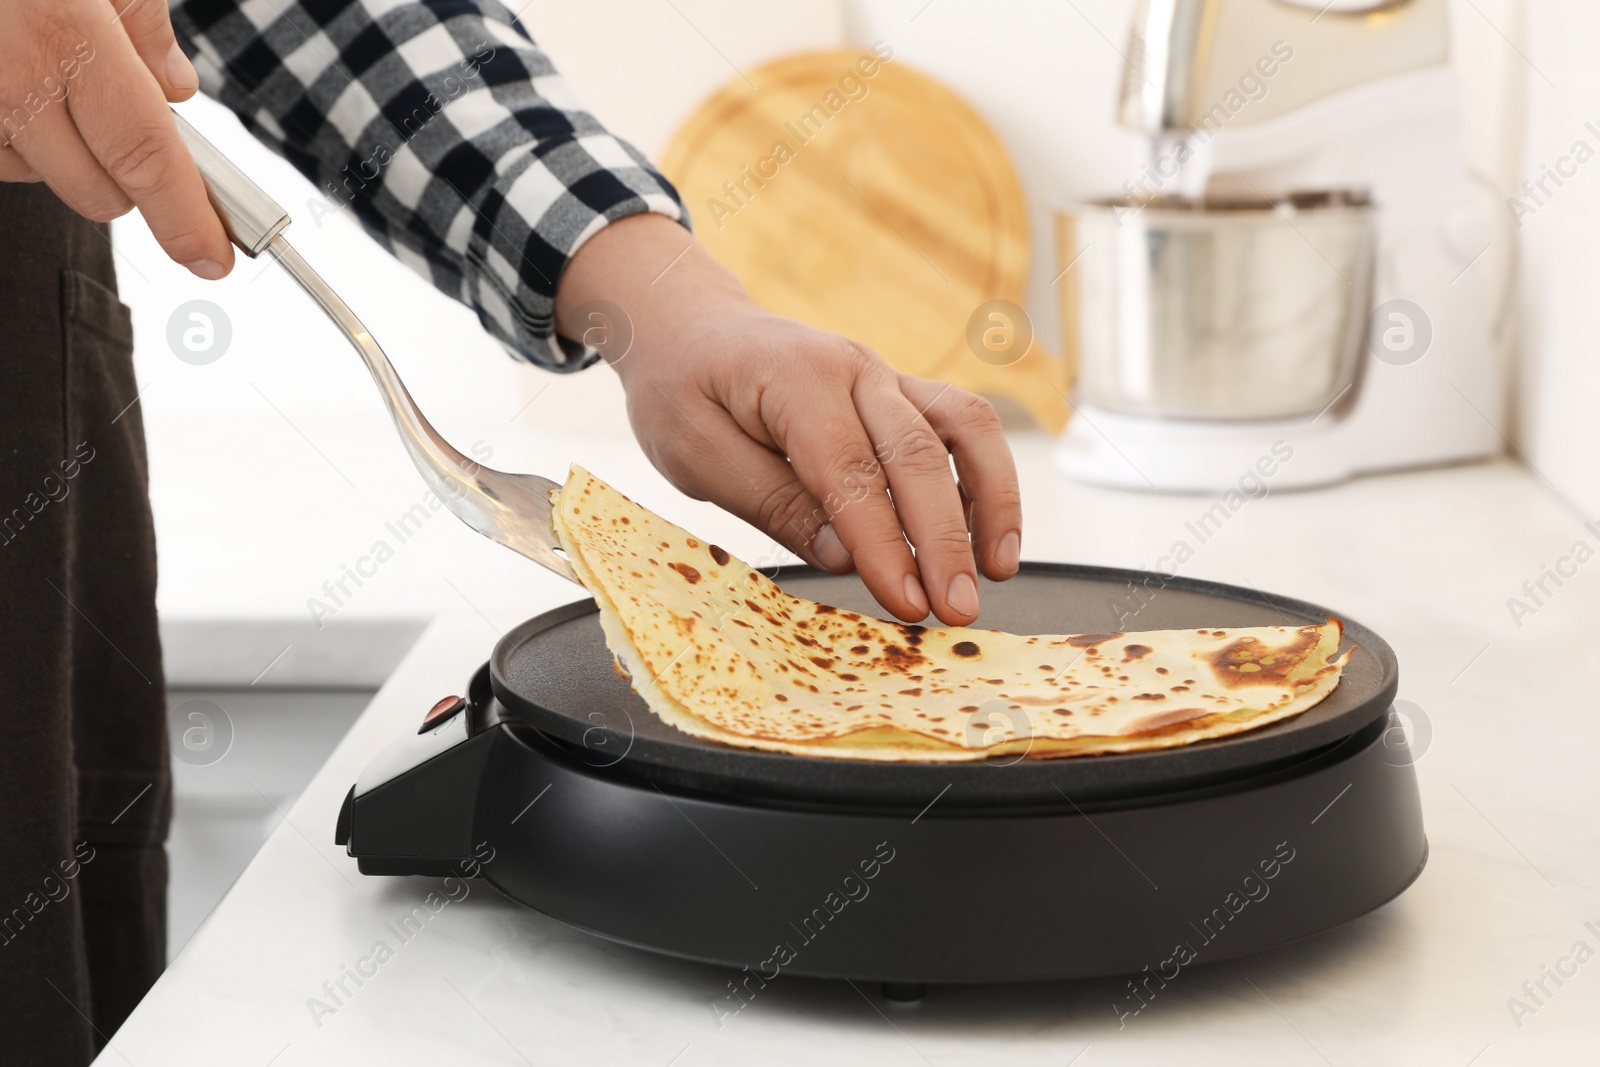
[65,13,234,278]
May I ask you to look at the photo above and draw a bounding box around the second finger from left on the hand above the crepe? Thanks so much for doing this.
[778,367,934,622]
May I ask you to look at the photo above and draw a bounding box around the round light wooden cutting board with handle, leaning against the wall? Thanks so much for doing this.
[661,50,1067,430]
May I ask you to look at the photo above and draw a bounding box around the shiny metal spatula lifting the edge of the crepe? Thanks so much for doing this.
[173,112,578,582]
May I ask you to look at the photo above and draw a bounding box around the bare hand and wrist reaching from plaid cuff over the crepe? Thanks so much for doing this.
[557,214,1022,624]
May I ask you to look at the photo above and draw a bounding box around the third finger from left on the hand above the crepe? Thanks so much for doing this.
[854,370,978,625]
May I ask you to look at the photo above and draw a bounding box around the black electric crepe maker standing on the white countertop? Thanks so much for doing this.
[338,565,1427,991]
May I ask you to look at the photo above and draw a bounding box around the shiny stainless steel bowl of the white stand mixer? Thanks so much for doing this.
[1058,190,1376,419]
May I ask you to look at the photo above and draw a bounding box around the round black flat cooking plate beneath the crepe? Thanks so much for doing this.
[490,563,1398,811]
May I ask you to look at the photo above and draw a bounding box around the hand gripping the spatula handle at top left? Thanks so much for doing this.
[0,0,234,278]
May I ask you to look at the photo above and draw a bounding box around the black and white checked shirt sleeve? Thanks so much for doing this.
[171,0,688,370]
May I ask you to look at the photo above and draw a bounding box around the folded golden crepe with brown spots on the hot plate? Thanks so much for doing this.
[550,467,1349,760]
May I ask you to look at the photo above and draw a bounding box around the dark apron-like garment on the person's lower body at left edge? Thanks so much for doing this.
[0,182,171,1065]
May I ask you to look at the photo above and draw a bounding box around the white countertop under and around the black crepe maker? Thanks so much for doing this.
[98,454,1600,1067]
